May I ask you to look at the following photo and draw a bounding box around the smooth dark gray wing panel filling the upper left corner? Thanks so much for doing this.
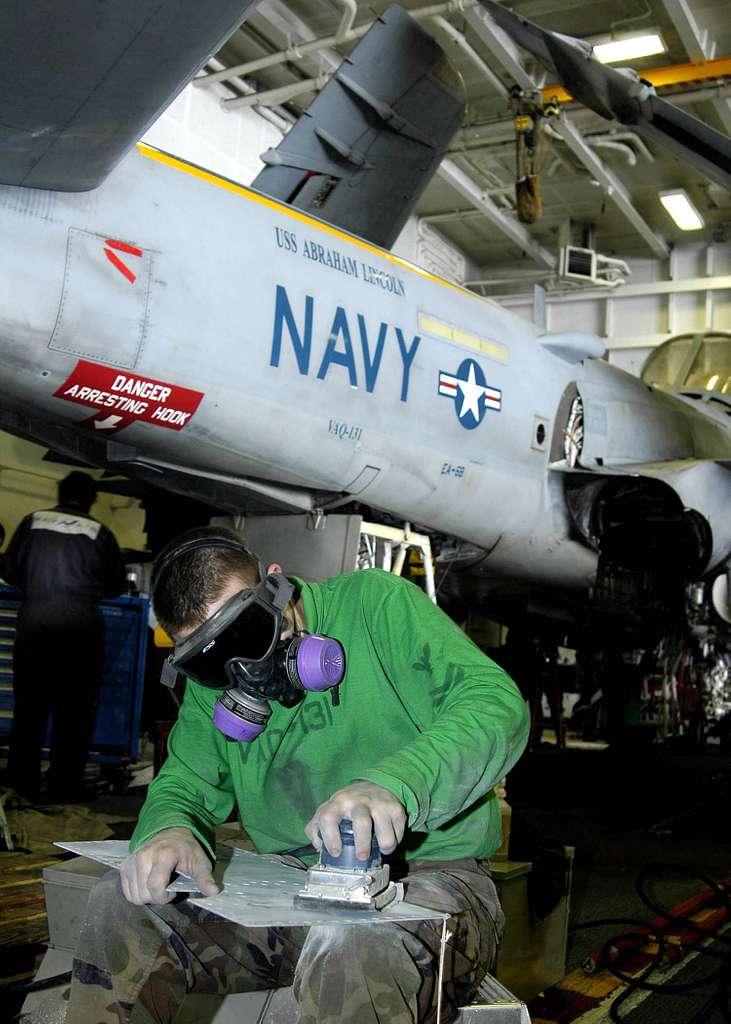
[0,0,258,191]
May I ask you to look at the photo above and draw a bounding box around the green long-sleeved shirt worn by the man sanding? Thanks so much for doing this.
[131,569,528,860]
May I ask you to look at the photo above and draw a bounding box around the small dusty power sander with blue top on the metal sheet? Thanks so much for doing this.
[295,818,403,910]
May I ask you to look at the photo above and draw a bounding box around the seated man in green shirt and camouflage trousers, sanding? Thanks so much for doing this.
[67,527,528,1024]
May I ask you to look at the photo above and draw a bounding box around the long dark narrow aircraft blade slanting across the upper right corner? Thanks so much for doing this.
[480,0,731,188]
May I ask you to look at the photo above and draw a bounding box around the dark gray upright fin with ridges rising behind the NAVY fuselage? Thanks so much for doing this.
[253,6,465,248]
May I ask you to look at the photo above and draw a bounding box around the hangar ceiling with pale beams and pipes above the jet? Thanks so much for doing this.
[196,0,731,275]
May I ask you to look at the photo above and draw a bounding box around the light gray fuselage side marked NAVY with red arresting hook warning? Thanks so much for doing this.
[0,146,725,586]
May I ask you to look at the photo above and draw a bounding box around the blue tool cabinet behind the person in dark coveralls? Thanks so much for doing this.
[0,586,149,765]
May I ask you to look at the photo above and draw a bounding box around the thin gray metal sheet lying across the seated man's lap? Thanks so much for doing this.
[56,840,447,928]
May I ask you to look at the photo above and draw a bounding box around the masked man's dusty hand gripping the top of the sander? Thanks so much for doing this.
[305,782,406,860]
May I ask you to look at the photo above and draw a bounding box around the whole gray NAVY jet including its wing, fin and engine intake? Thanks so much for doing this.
[0,0,731,626]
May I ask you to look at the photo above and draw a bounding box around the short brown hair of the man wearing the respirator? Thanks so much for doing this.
[152,526,262,637]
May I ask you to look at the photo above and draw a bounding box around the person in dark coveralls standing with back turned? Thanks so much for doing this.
[3,471,125,801]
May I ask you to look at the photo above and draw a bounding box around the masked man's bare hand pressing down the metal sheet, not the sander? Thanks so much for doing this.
[120,828,220,906]
